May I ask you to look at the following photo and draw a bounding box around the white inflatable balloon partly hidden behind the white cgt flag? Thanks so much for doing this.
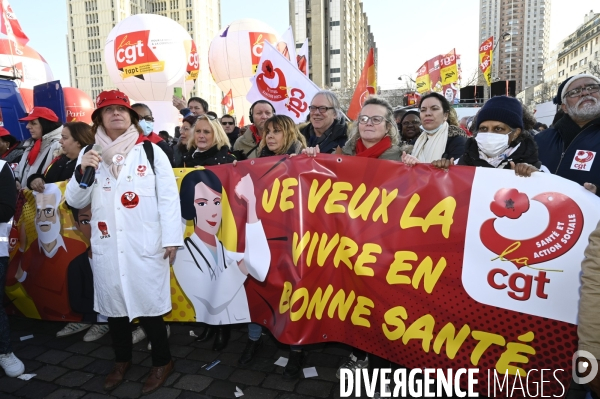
[208,18,277,123]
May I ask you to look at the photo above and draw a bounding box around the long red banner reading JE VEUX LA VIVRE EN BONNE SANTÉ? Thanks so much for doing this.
[6,158,600,397]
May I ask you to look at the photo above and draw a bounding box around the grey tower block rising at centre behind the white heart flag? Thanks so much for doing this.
[289,0,377,89]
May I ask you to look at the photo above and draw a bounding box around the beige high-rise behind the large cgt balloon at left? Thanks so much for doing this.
[66,0,221,109]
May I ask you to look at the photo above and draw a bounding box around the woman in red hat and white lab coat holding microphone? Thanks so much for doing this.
[66,90,183,393]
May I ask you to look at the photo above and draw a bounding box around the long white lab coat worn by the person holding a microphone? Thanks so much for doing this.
[66,143,183,319]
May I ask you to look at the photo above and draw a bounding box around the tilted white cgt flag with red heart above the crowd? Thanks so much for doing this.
[246,41,320,123]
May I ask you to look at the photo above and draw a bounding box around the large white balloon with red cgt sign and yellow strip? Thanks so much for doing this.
[104,14,191,102]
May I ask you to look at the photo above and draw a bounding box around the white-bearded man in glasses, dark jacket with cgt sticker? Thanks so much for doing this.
[535,74,600,195]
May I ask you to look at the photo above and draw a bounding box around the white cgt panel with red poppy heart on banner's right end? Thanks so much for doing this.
[462,168,597,324]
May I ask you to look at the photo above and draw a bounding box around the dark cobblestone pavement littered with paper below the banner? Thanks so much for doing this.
[0,317,585,399]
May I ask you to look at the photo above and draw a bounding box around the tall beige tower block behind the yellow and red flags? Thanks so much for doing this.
[479,0,550,93]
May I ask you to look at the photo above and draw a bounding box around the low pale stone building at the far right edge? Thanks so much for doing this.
[556,11,600,82]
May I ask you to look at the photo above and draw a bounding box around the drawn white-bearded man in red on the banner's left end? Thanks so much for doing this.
[16,184,86,320]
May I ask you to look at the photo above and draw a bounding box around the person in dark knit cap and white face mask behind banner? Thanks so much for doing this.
[432,96,542,176]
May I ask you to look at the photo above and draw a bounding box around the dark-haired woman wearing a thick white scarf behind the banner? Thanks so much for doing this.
[412,92,467,163]
